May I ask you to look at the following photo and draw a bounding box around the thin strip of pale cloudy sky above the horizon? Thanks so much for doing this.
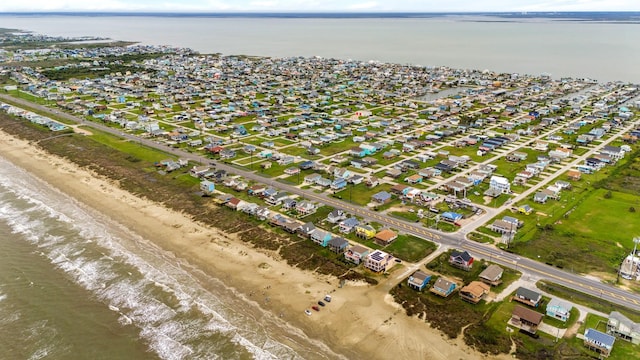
[0,0,640,12]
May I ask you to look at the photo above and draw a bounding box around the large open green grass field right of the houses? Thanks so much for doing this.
[506,187,640,277]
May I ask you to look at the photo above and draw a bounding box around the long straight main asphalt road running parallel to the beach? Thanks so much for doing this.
[5,94,640,311]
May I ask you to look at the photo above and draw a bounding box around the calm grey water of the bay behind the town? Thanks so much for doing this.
[0,13,640,83]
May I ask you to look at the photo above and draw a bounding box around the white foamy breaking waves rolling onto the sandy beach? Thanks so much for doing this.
[0,159,299,359]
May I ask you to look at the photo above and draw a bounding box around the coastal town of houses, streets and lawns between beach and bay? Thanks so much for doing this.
[0,32,640,359]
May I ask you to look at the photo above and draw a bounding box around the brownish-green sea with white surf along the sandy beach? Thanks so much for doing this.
[0,158,331,360]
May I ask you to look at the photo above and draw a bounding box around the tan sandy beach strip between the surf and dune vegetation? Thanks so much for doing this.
[0,133,507,359]
